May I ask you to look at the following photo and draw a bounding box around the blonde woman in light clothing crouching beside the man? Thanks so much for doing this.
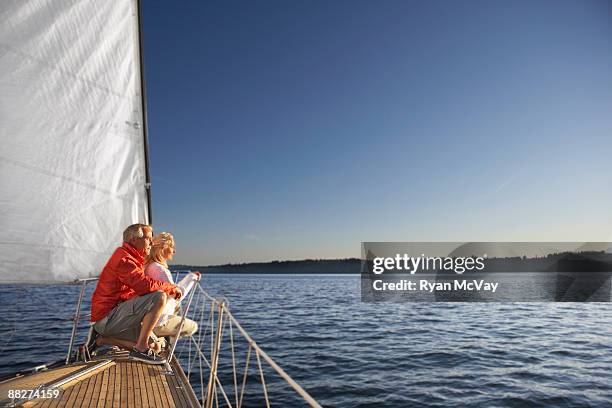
[145,232,200,337]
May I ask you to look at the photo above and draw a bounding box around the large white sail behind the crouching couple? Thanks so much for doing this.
[0,0,148,282]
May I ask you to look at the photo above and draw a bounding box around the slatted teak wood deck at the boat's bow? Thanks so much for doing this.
[2,359,200,408]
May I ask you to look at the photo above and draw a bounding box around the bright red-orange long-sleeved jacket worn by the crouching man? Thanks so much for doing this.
[91,242,179,322]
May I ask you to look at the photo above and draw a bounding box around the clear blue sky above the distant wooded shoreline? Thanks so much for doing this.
[143,0,612,265]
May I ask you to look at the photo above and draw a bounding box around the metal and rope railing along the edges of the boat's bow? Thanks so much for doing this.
[67,279,320,408]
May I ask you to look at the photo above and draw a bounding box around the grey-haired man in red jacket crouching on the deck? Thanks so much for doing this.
[91,224,182,364]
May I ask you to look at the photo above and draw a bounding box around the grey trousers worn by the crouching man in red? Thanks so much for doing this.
[93,291,163,342]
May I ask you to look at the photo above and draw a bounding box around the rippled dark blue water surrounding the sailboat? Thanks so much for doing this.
[0,275,612,407]
